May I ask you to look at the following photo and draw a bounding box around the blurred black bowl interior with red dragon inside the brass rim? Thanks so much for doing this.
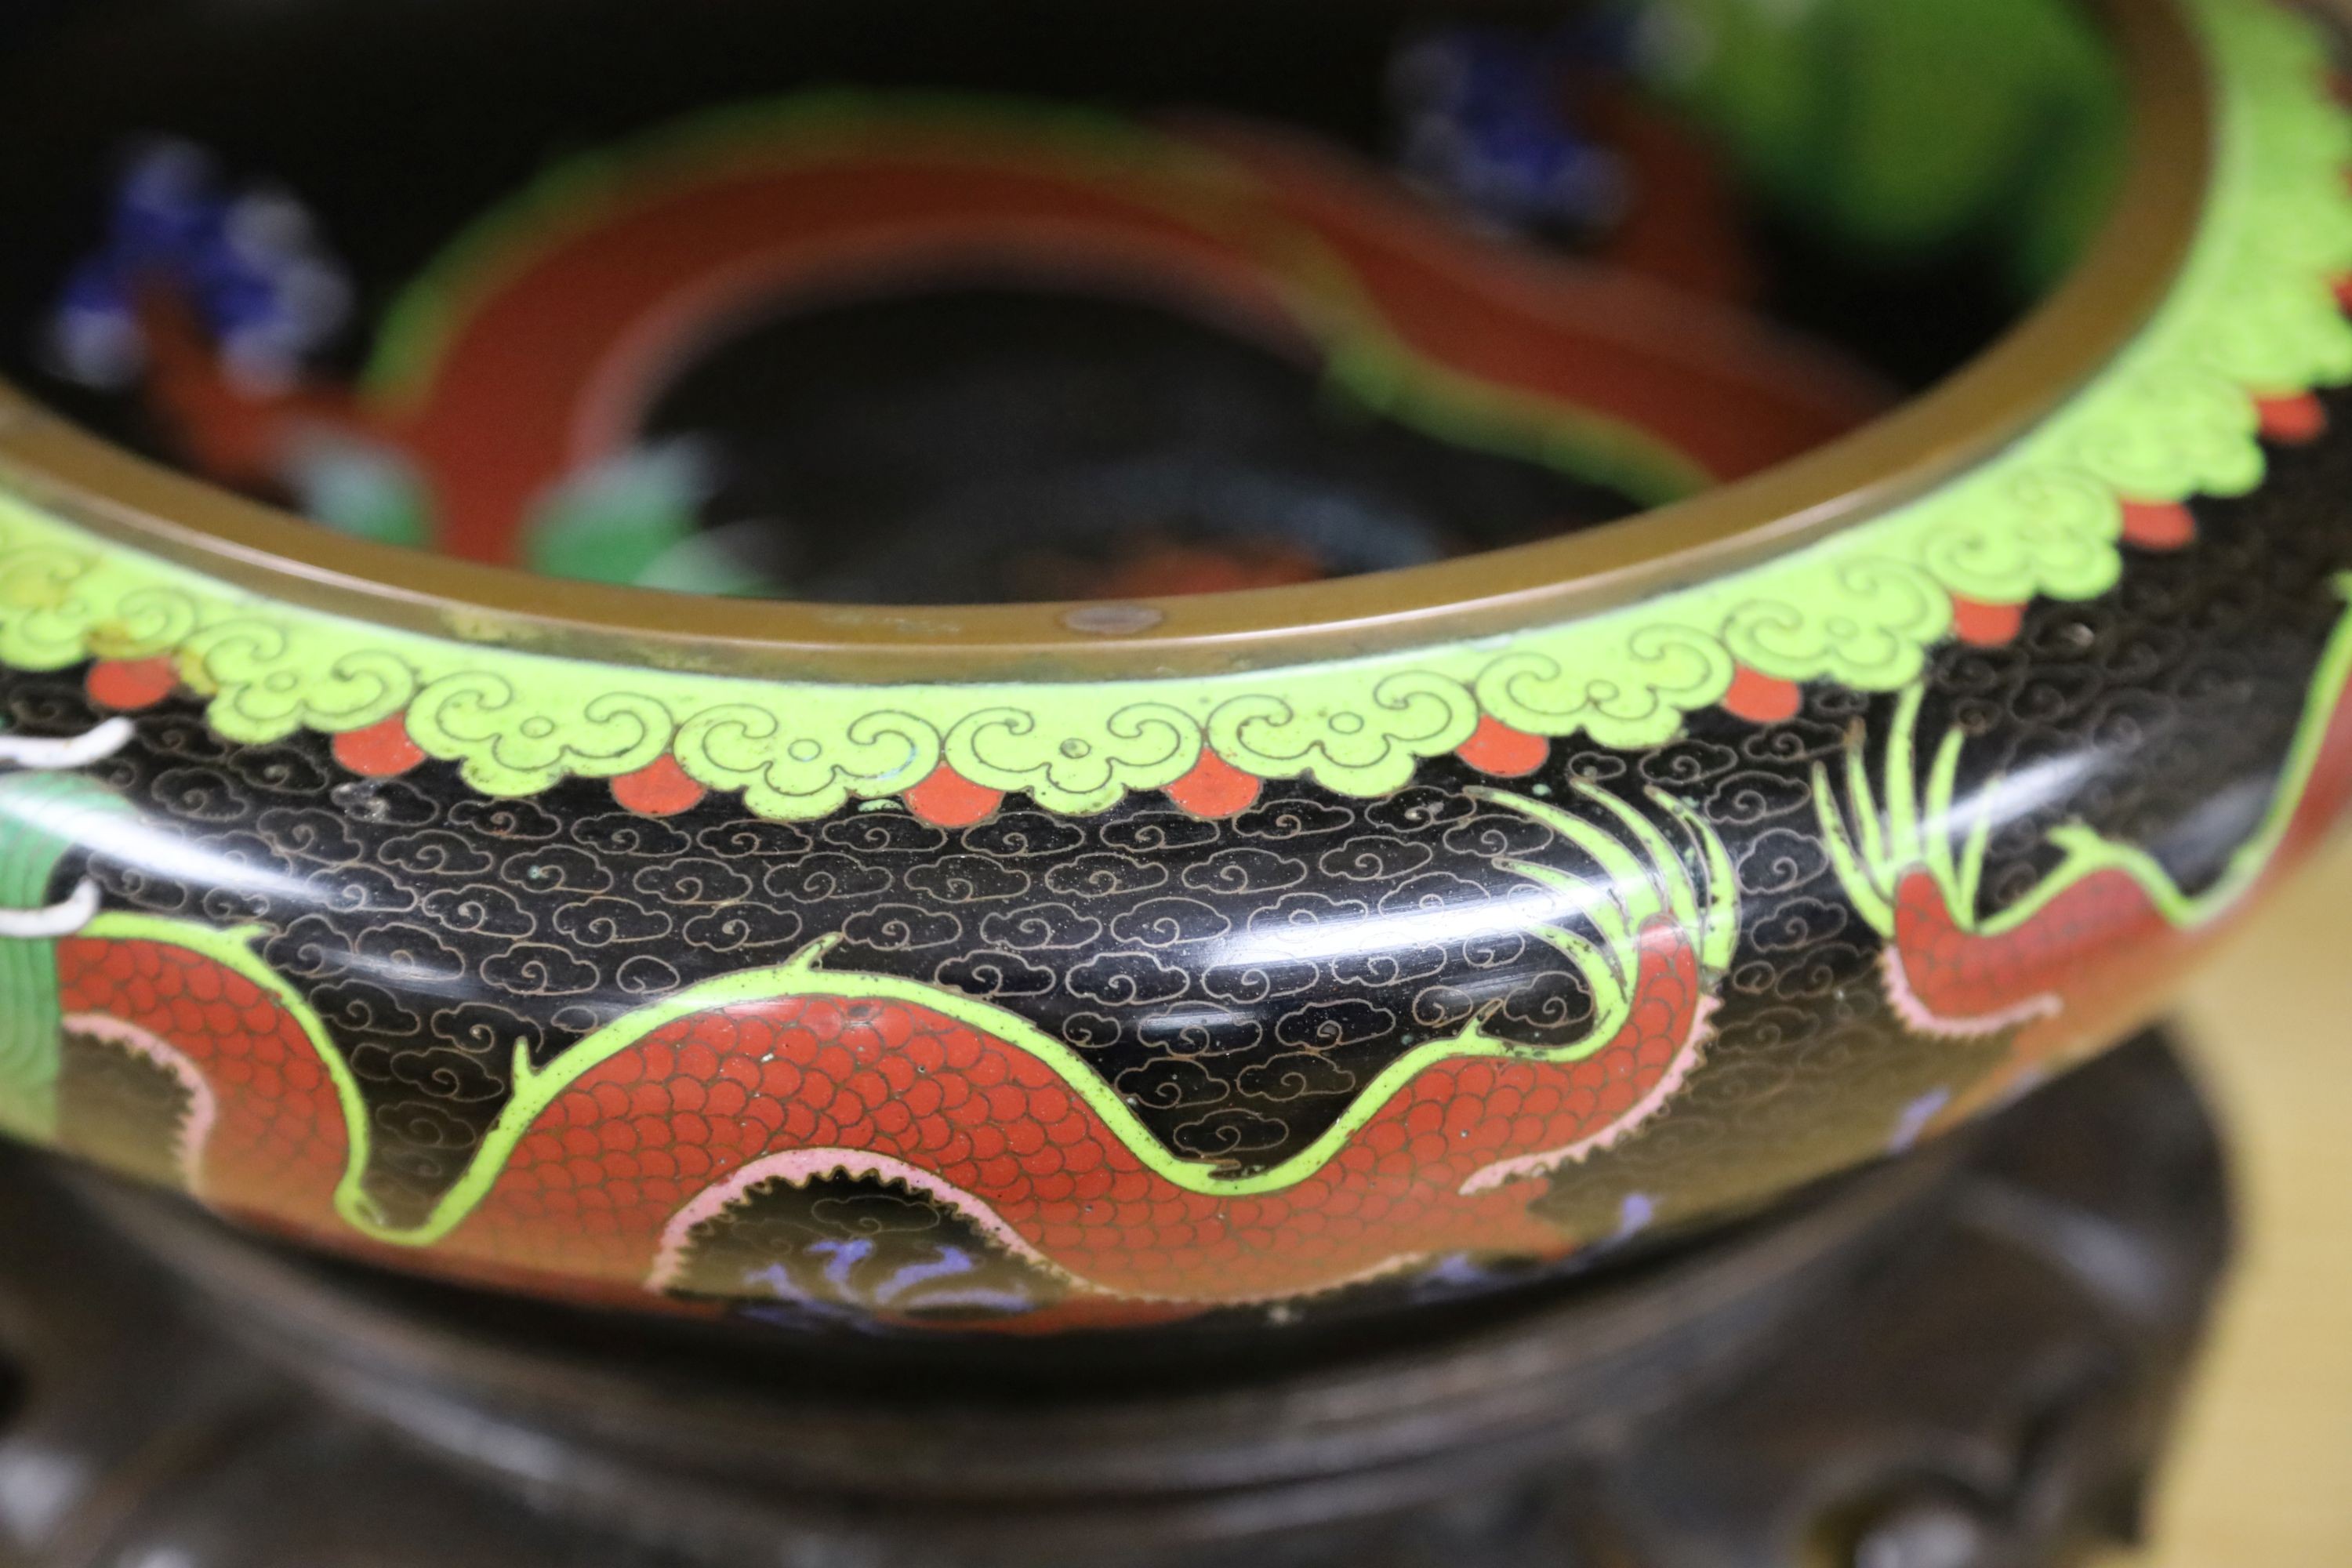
[0,0,2129,604]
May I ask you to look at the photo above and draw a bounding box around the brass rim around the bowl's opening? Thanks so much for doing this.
[0,0,2213,682]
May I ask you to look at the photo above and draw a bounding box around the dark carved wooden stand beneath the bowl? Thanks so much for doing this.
[0,1039,2227,1568]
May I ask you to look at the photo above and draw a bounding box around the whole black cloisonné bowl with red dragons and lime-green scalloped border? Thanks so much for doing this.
[0,0,2352,1330]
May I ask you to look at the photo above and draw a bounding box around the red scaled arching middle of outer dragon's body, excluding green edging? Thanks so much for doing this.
[442,921,1703,1302]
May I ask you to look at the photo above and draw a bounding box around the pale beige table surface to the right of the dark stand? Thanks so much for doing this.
[2129,839,2352,1568]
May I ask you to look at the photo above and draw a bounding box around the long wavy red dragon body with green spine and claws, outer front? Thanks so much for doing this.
[27,785,1738,1321]
